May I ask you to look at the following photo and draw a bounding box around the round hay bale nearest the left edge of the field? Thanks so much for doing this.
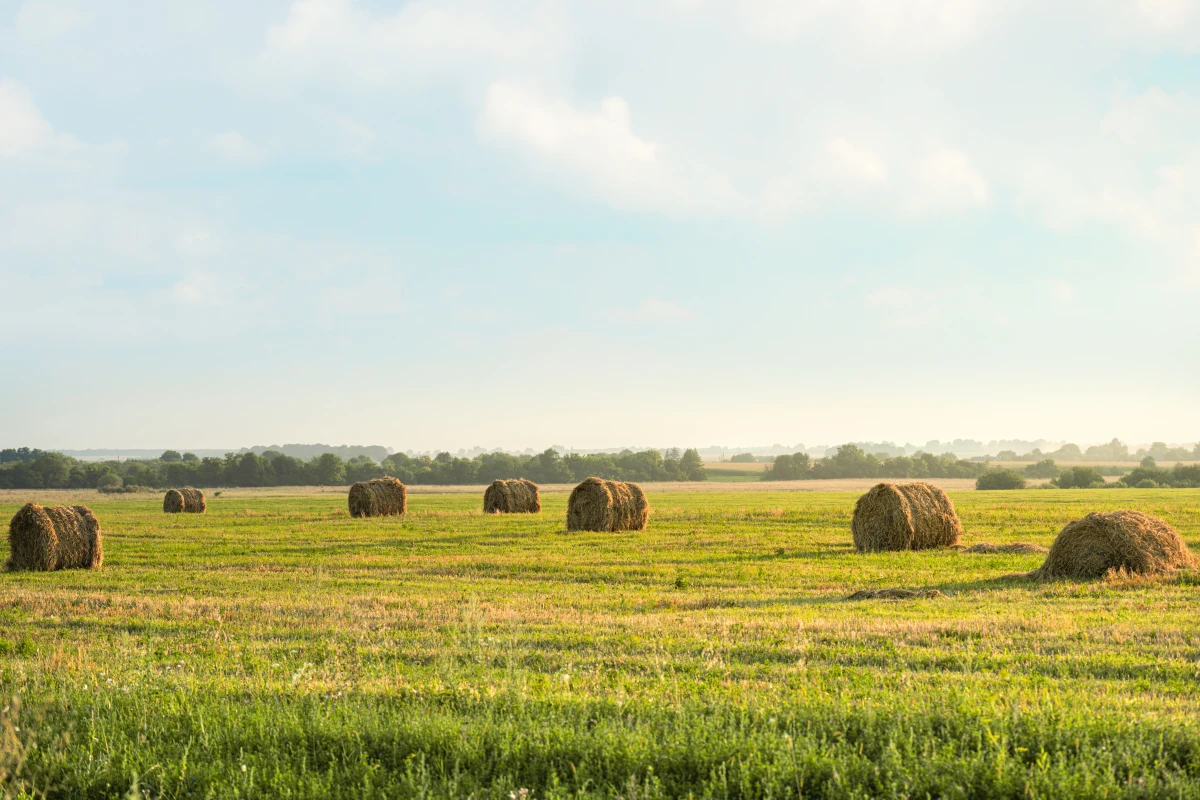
[7,503,104,572]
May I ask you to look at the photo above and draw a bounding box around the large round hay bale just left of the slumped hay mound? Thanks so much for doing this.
[850,482,962,552]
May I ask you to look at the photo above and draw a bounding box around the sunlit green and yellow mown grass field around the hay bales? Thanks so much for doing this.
[0,489,1200,800]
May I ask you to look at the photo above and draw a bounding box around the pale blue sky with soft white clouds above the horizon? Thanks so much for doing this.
[0,0,1200,450]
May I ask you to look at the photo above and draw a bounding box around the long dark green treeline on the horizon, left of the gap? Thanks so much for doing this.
[0,447,707,489]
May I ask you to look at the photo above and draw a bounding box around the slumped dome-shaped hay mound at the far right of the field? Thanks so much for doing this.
[1030,511,1196,581]
